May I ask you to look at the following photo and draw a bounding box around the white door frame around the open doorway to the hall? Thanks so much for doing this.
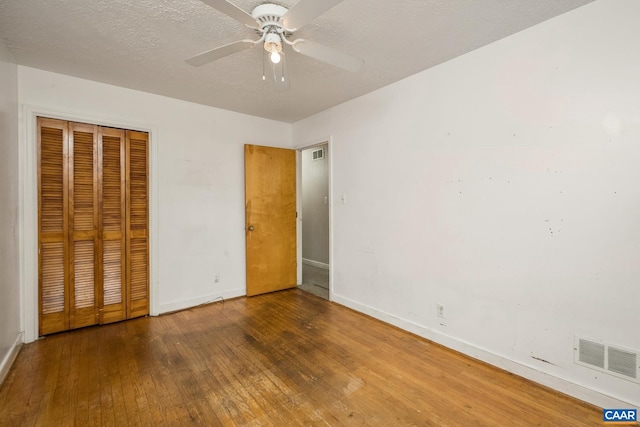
[293,136,333,301]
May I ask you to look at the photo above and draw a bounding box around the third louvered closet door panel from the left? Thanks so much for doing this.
[98,128,127,323]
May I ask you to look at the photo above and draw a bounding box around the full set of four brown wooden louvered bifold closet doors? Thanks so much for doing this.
[38,118,149,335]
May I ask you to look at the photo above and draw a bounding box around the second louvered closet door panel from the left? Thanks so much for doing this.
[69,123,102,329]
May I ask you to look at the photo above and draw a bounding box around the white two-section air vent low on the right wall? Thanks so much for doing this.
[574,336,640,382]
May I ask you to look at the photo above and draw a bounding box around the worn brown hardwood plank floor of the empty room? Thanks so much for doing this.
[0,289,602,426]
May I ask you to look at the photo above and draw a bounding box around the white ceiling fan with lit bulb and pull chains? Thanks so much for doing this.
[186,0,364,84]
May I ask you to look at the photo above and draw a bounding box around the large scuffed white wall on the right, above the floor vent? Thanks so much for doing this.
[293,0,640,406]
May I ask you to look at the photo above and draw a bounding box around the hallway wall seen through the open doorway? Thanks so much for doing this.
[301,144,329,266]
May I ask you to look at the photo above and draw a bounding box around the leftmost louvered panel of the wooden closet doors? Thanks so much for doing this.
[38,118,69,335]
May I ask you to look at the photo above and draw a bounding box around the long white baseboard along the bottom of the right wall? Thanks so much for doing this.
[331,293,638,408]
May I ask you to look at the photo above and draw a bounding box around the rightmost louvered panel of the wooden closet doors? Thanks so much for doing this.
[126,131,149,318]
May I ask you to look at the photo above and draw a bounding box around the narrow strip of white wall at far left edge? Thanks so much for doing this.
[0,42,22,382]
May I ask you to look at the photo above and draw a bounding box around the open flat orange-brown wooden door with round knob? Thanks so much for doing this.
[244,145,297,296]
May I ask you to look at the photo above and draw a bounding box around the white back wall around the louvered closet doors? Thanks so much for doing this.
[18,67,291,339]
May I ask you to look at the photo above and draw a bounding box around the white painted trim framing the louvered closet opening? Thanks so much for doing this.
[18,104,159,343]
